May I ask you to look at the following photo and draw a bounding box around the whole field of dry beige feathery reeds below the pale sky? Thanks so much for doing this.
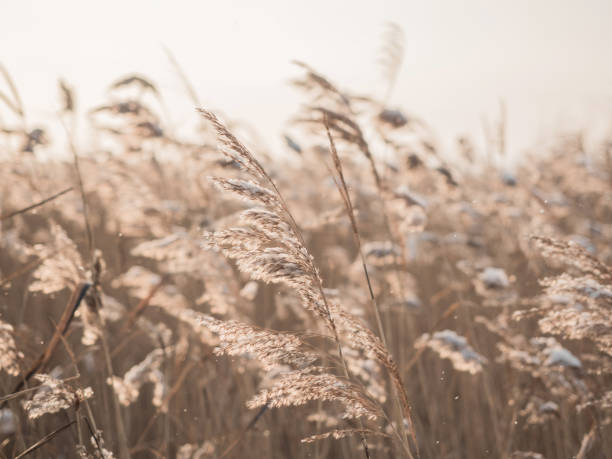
[0,51,612,458]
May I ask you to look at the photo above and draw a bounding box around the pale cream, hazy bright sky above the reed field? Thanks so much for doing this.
[0,0,612,156]
